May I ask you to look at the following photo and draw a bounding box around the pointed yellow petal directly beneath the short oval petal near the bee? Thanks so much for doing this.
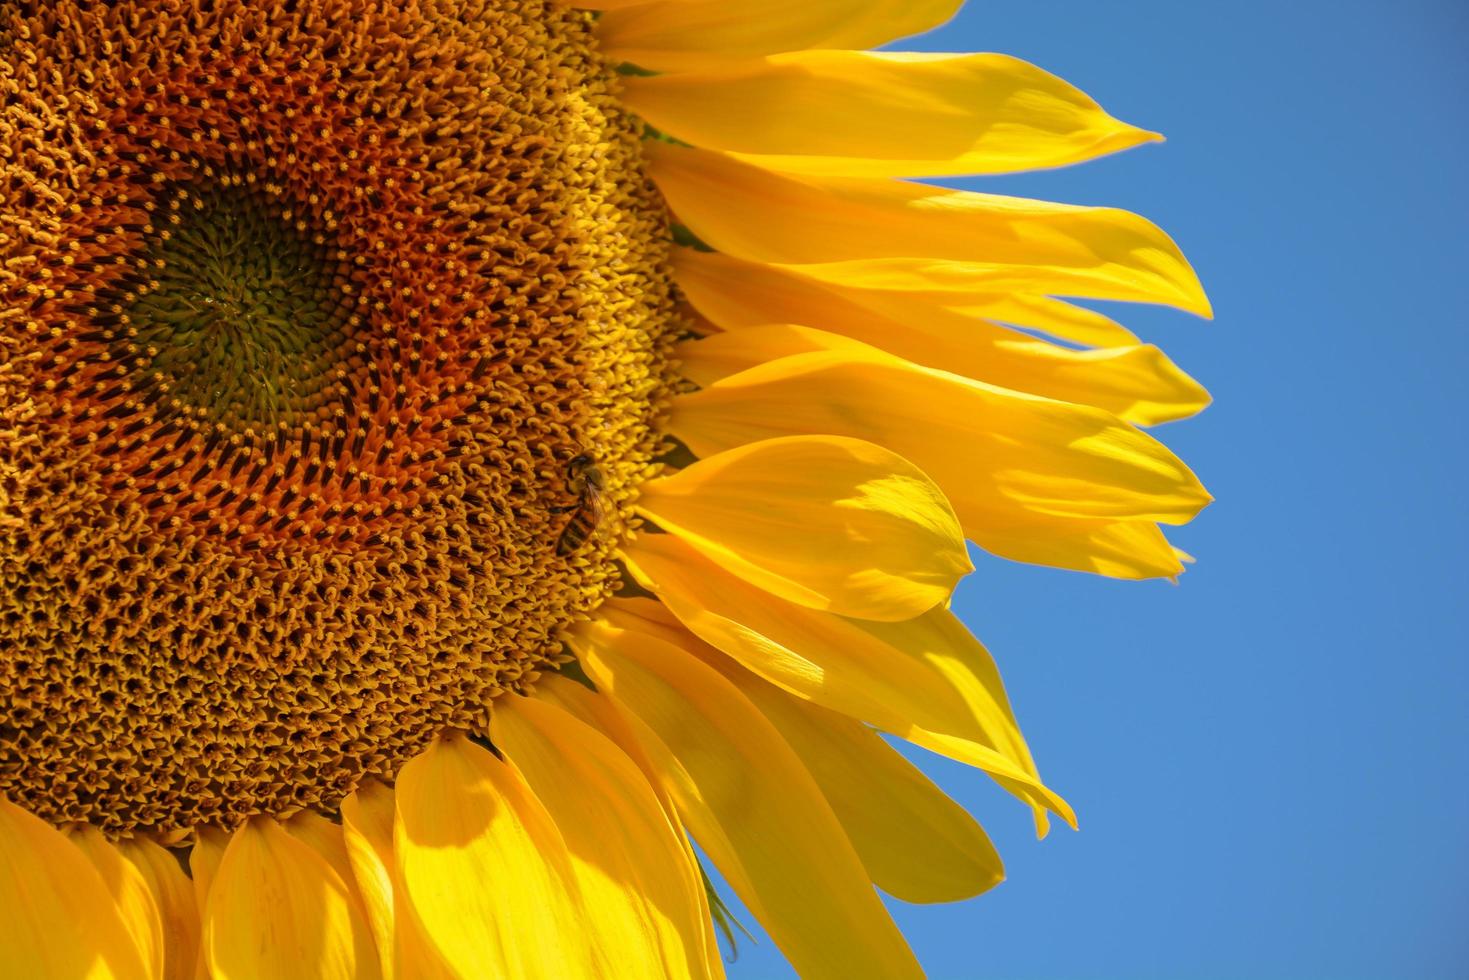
[610,535,1074,821]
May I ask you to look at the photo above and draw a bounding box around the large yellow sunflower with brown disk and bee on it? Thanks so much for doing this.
[0,0,1209,980]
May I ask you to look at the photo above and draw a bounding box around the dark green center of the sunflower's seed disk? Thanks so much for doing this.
[123,182,357,430]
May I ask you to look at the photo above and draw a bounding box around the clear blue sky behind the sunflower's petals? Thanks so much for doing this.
[716,0,1469,980]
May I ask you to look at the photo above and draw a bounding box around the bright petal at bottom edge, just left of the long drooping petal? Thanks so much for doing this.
[491,698,717,977]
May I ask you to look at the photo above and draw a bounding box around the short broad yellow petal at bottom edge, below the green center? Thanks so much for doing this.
[201,817,380,980]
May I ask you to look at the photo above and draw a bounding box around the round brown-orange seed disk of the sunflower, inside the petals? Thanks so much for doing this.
[0,0,676,832]
